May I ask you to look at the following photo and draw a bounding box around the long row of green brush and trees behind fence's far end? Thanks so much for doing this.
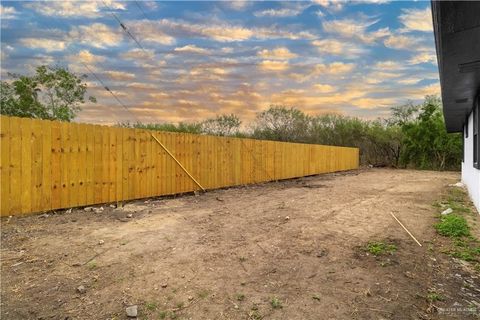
[116,96,462,170]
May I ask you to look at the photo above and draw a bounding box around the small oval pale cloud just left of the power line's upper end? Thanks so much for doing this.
[69,23,123,48]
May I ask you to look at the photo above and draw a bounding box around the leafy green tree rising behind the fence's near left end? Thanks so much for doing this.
[0,66,96,121]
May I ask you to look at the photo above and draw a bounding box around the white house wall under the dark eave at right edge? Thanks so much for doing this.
[462,112,480,212]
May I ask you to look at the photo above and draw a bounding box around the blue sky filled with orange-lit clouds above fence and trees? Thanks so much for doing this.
[1,0,440,124]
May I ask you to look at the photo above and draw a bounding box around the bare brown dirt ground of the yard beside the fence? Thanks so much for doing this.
[1,169,480,319]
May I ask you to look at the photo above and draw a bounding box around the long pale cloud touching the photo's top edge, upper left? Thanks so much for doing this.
[24,0,125,18]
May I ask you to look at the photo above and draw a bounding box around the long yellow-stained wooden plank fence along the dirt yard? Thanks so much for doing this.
[0,116,358,216]
